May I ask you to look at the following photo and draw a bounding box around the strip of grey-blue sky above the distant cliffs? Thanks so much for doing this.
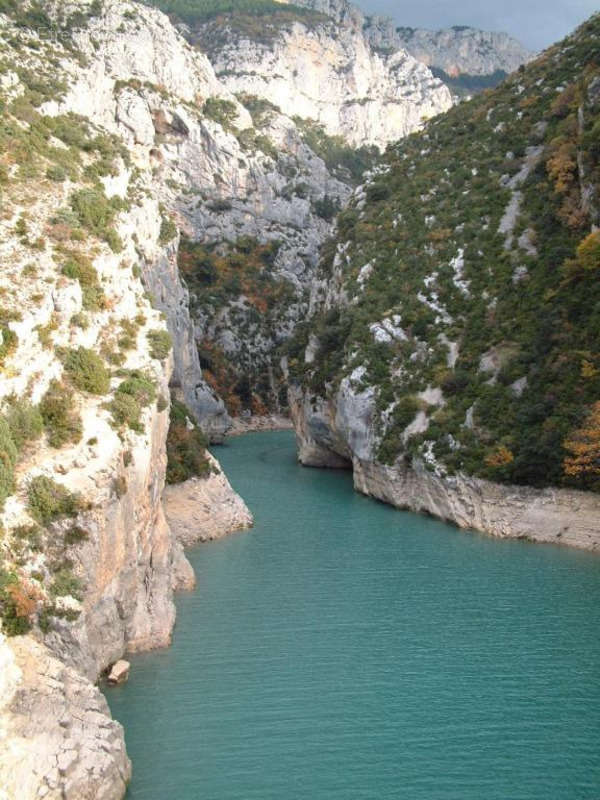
[354,0,600,51]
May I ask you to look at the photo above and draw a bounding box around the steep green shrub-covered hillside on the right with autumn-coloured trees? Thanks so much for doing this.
[290,15,600,489]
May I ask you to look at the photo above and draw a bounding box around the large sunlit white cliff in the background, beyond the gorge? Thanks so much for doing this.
[188,1,451,148]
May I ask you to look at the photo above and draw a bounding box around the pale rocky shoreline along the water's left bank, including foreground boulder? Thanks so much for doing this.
[0,457,252,800]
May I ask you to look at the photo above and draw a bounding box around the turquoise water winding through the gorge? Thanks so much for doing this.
[107,432,600,800]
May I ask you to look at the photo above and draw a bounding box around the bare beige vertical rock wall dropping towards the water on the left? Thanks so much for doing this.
[45,376,180,680]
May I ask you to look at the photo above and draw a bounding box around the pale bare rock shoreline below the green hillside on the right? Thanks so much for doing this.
[290,385,600,552]
